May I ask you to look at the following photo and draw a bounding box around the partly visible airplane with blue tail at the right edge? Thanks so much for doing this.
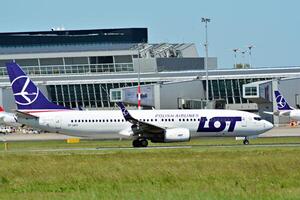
[265,90,300,121]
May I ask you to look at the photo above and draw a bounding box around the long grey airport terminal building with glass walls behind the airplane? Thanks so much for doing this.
[0,28,300,121]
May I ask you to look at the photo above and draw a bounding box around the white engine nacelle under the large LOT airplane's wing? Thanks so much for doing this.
[164,128,191,142]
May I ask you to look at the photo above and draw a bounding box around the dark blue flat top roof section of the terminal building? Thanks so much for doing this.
[0,28,148,47]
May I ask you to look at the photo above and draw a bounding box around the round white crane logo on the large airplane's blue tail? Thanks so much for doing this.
[12,76,39,105]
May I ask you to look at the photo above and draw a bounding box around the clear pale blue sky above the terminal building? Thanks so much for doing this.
[0,0,300,68]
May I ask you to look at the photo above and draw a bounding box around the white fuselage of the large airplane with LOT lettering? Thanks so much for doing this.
[20,110,273,138]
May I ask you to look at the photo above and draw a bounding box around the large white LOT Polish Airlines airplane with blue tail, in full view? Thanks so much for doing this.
[6,61,273,147]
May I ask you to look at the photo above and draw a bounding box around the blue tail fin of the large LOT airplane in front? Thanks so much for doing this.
[6,62,68,111]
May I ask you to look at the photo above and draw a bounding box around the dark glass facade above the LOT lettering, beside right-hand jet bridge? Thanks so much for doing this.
[206,78,268,104]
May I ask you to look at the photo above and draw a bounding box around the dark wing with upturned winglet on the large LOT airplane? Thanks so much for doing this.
[117,102,166,135]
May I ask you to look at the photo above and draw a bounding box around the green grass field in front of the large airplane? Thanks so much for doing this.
[0,138,300,199]
